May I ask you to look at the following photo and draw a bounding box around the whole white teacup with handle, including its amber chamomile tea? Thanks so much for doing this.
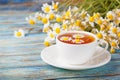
[56,31,108,65]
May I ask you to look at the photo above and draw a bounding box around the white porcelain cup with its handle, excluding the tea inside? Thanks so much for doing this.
[56,31,108,65]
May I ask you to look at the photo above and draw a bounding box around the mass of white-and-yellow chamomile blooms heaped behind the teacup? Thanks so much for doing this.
[26,1,120,53]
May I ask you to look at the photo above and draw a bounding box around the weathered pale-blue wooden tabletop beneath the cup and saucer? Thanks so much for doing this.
[0,11,120,80]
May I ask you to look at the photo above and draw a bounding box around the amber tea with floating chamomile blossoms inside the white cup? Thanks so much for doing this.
[58,33,95,44]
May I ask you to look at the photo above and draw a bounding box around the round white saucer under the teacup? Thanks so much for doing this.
[41,45,111,70]
